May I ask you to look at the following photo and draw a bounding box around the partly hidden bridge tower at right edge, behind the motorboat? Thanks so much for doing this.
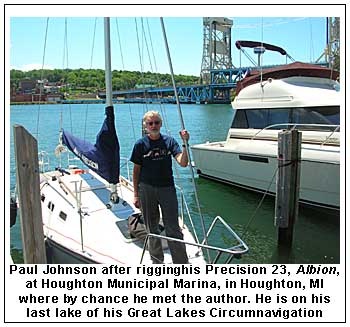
[316,17,340,69]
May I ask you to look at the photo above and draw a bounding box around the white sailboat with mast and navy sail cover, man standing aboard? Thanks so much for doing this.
[36,18,248,265]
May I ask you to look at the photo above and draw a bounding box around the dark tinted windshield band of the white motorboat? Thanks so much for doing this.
[231,106,340,131]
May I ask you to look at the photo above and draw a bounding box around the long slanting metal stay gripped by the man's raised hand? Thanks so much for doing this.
[160,17,211,262]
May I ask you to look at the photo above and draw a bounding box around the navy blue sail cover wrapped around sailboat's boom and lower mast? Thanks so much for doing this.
[62,106,120,184]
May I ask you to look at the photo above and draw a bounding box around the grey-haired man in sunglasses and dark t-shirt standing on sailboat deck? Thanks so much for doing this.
[130,111,190,264]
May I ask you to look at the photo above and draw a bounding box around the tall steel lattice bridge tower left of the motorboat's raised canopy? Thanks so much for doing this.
[201,17,233,83]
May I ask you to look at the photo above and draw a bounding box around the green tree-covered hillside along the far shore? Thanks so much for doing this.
[10,68,199,92]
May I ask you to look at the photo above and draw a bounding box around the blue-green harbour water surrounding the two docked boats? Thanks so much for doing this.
[10,104,340,264]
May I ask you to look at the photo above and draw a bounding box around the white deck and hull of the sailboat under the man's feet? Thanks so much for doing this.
[41,170,205,265]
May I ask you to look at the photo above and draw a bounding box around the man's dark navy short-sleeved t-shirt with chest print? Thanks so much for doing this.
[130,134,182,186]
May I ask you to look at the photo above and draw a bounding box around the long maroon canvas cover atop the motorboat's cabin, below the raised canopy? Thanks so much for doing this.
[236,61,339,96]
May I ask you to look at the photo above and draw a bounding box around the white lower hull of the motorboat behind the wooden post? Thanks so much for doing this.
[191,140,340,209]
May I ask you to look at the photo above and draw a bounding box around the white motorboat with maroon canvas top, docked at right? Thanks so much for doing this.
[191,62,341,210]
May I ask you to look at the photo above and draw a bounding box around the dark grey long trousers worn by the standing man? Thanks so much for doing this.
[139,183,188,264]
